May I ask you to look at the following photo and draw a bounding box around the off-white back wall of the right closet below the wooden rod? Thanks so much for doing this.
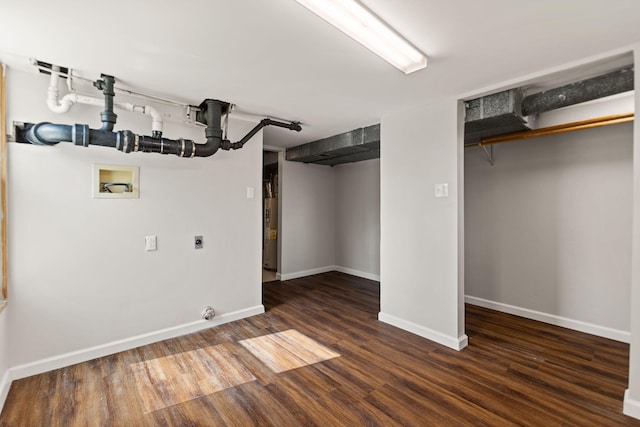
[465,124,632,340]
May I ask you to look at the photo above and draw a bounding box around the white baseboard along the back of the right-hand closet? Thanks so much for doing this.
[464,295,631,343]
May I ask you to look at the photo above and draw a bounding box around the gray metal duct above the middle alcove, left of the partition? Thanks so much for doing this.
[286,124,380,166]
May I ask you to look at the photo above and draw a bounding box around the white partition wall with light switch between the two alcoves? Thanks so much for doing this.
[379,98,466,348]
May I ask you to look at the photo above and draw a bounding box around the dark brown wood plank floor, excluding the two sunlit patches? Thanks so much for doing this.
[0,273,640,427]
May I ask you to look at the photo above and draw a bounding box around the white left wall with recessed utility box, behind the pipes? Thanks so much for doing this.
[0,70,264,375]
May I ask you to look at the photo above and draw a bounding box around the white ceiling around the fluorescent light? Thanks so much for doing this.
[0,0,640,146]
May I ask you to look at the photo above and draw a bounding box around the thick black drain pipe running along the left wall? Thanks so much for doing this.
[16,75,302,157]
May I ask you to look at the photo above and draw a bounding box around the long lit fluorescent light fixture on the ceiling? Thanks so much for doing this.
[296,0,427,74]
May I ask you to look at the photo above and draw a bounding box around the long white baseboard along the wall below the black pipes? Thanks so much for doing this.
[9,304,264,380]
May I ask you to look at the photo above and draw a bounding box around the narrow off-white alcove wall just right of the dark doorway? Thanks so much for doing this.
[278,161,336,280]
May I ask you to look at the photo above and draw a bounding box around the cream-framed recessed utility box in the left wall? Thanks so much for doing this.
[92,164,140,199]
